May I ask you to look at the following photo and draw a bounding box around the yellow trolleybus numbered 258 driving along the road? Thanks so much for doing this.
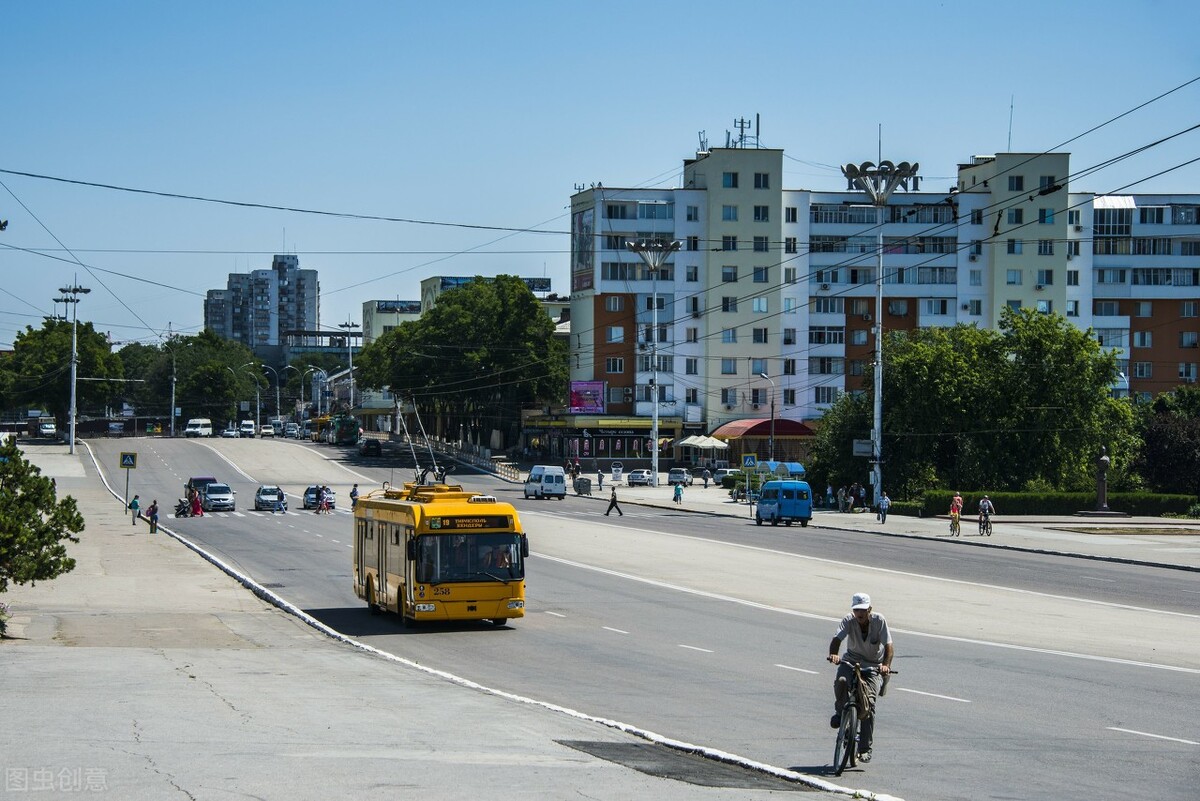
[354,483,529,626]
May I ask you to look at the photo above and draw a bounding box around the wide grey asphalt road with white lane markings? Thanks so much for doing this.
[95,440,1200,800]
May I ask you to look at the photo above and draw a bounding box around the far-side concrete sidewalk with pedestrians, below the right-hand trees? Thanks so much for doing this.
[592,474,1200,571]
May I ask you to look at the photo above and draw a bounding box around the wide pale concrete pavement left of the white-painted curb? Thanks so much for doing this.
[0,446,833,801]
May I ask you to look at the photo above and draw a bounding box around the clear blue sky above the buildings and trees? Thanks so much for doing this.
[0,0,1200,347]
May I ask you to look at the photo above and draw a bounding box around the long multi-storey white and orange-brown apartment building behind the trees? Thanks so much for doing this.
[549,140,1200,456]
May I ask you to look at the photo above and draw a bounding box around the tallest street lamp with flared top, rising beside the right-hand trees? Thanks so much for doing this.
[841,159,920,504]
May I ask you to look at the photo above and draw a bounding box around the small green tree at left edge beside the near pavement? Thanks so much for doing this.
[0,438,84,631]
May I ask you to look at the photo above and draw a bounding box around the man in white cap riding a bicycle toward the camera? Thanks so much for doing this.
[826,592,895,763]
